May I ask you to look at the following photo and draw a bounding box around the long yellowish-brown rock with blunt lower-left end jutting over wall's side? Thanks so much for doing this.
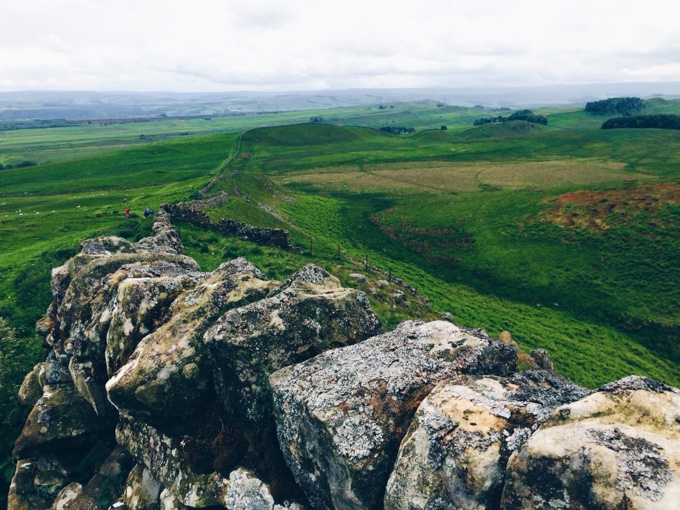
[106,258,277,419]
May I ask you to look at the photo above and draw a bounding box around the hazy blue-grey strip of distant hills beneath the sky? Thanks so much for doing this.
[0,82,680,121]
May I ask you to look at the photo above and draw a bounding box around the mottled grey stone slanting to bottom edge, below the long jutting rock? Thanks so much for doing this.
[116,418,216,508]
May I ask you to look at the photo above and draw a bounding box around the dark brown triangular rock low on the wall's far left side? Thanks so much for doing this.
[14,384,115,458]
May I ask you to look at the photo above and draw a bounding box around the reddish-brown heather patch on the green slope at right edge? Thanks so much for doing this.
[545,184,680,231]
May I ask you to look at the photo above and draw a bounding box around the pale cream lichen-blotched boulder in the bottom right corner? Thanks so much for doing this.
[501,377,680,510]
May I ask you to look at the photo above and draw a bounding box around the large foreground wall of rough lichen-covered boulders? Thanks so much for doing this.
[8,214,680,510]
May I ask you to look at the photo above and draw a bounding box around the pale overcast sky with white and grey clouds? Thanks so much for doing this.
[0,0,680,92]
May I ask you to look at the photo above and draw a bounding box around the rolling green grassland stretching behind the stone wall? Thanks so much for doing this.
[0,95,680,506]
